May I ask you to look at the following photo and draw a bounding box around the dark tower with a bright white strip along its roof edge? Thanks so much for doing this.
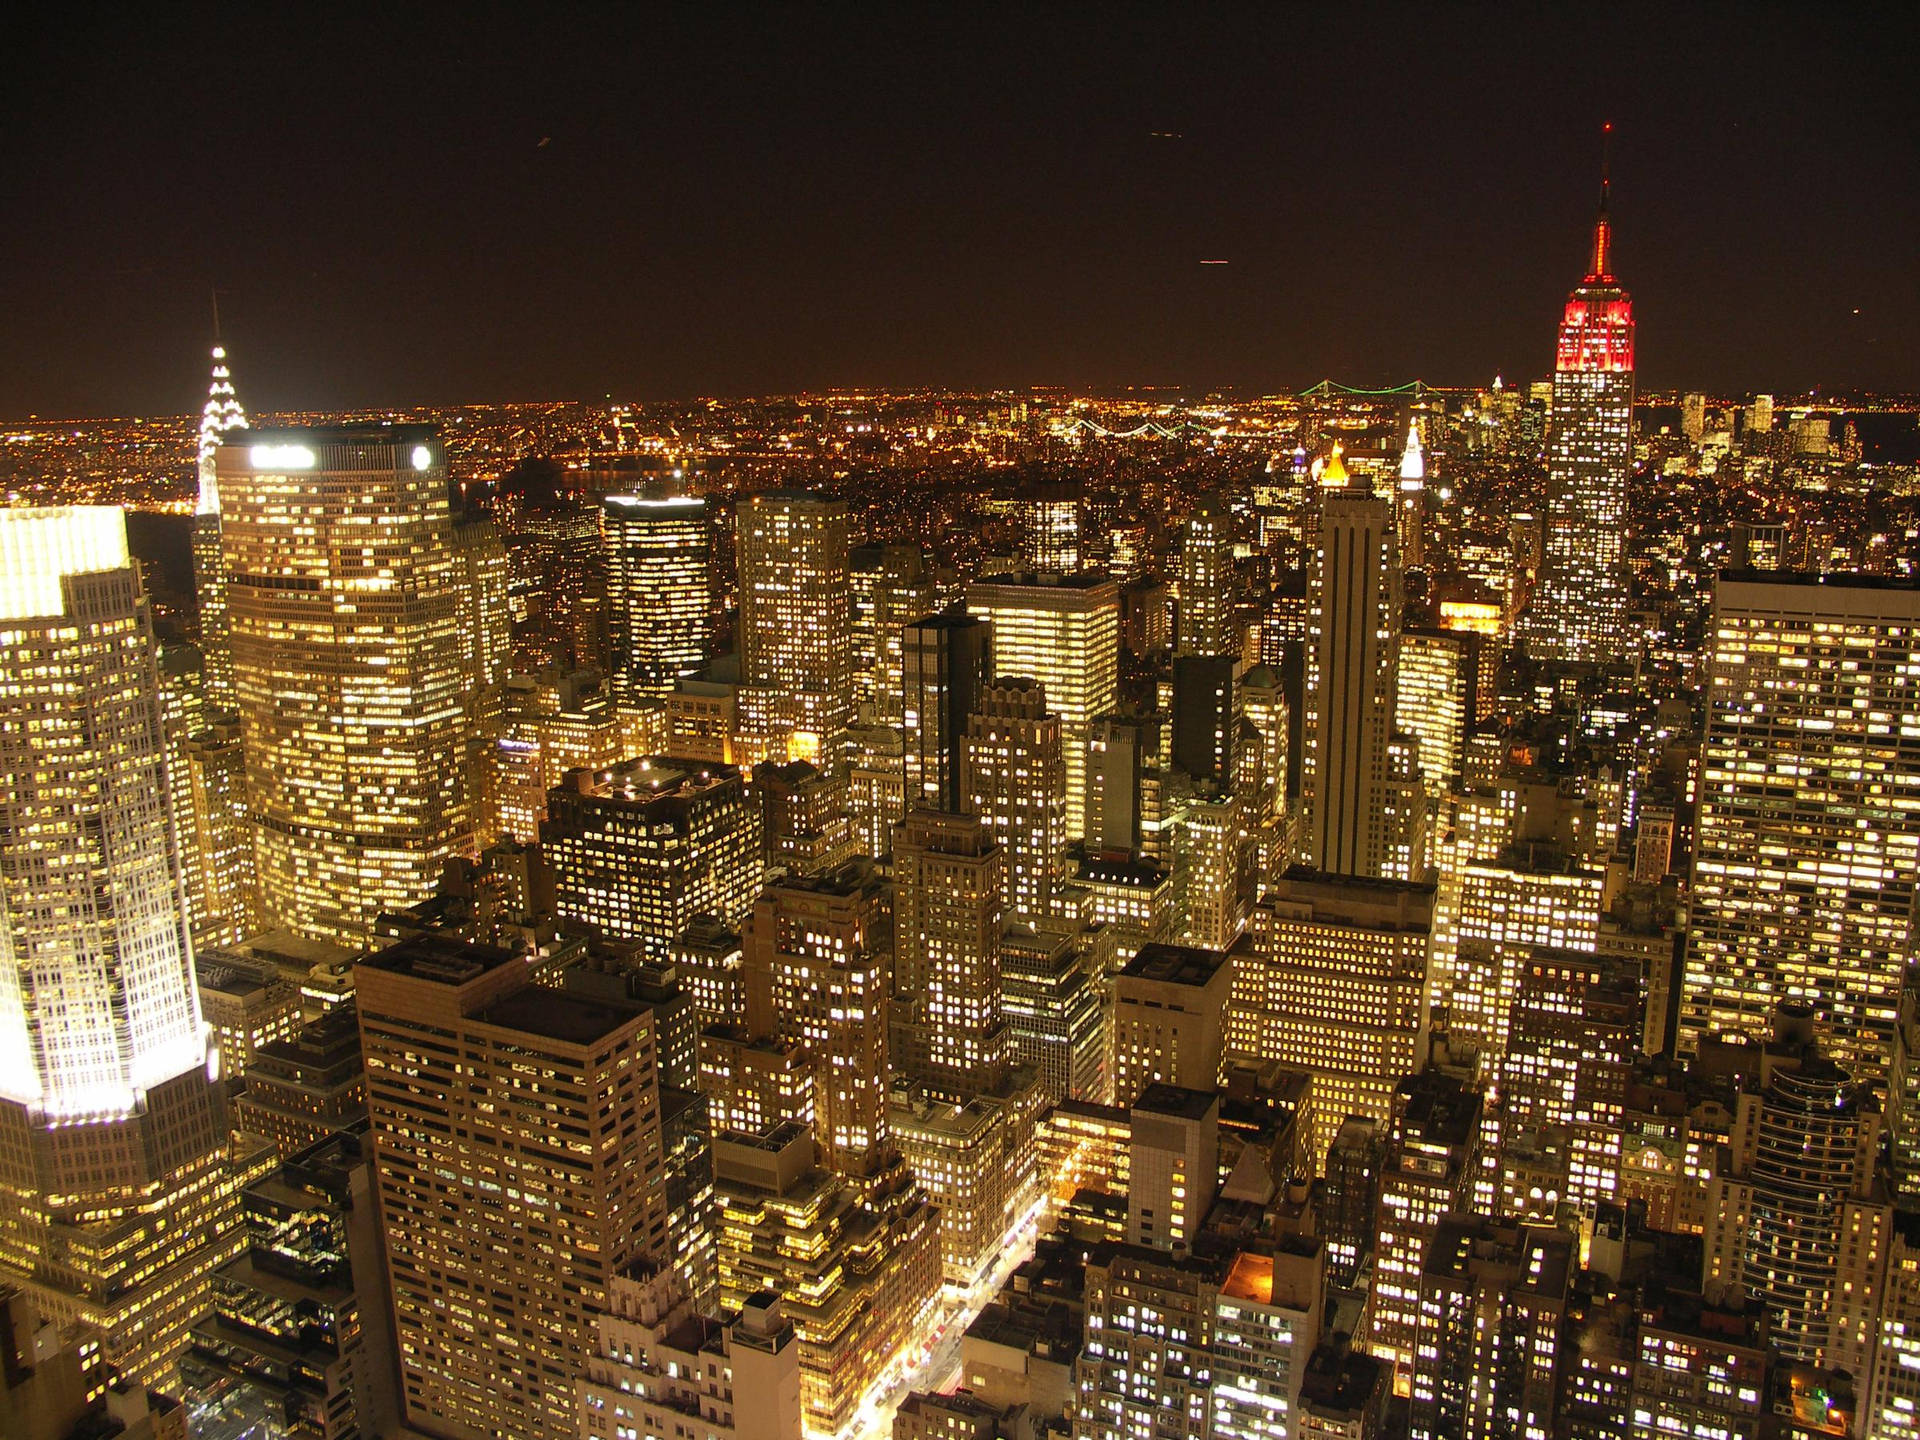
[603,495,712,703]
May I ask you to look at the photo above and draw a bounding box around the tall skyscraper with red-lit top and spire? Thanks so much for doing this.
[1524,152,1634,664]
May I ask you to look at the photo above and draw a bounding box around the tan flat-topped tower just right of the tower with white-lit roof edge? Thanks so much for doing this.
[733,492,854,768]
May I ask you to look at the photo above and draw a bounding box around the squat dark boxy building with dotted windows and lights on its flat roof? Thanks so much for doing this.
[541,756,762,954]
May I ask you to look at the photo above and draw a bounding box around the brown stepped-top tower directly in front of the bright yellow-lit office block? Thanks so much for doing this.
[960,680,1069,920]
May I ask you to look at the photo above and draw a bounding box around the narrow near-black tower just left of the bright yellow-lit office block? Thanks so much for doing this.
[900,614,993,810]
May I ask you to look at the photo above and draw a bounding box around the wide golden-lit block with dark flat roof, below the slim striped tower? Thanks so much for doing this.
[1227,868,1434,1171]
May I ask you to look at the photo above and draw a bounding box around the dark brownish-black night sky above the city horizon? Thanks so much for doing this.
[0,4,1920,419]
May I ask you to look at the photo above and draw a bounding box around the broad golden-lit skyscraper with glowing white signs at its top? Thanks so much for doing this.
[217,426,472,941]
